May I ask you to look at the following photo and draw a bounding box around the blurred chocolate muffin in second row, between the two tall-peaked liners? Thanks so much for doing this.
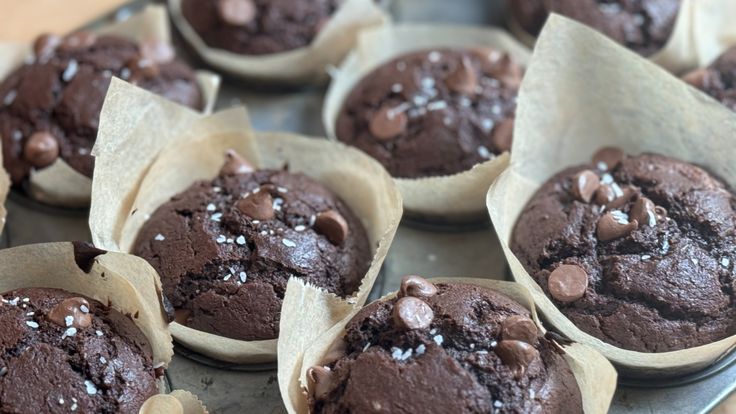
[335,48,522,178]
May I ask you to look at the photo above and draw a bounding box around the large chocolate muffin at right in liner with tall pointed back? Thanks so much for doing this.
[511,148,736,352]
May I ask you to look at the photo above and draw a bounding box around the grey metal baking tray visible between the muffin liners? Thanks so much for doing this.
[0,0,736,413]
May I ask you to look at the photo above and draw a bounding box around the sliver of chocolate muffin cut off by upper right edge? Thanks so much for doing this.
[683,47,736,111]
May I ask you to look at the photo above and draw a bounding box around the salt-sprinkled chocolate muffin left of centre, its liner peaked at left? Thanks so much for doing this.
[133,152,371,340]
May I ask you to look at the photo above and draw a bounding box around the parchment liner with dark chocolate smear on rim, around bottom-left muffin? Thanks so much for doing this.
[0,242,206,414]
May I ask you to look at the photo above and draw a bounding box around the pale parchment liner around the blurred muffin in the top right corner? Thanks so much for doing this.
[507,0,736,74]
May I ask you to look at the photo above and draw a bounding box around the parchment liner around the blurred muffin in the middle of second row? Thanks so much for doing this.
[322,25,530,222]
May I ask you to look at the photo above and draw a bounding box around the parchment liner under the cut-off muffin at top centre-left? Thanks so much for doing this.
[169,0,389,84]
